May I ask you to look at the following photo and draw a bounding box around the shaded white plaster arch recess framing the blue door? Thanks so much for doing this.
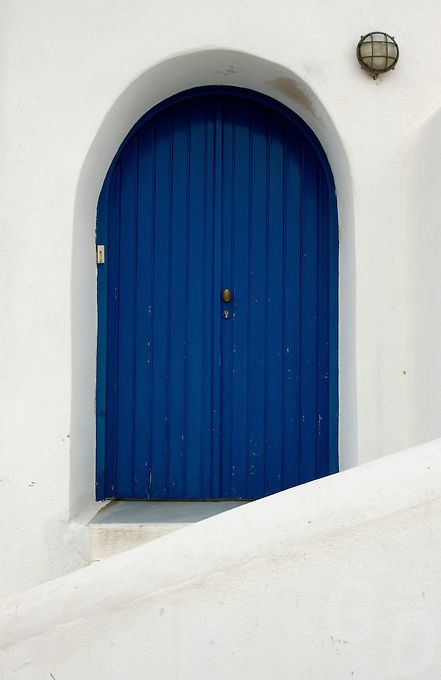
[70,49,357,516]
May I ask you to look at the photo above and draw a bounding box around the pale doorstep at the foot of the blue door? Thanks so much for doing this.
[88,501,247,561]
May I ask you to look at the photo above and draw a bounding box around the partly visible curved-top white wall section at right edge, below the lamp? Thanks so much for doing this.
[406,110,441,446]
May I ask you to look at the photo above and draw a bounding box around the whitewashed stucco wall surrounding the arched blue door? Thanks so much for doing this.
[0,0,441,593]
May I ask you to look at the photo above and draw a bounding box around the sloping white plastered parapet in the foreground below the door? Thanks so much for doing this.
[0,440,441,680]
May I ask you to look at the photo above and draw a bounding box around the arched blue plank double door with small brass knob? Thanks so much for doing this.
[97,88,338,499]
